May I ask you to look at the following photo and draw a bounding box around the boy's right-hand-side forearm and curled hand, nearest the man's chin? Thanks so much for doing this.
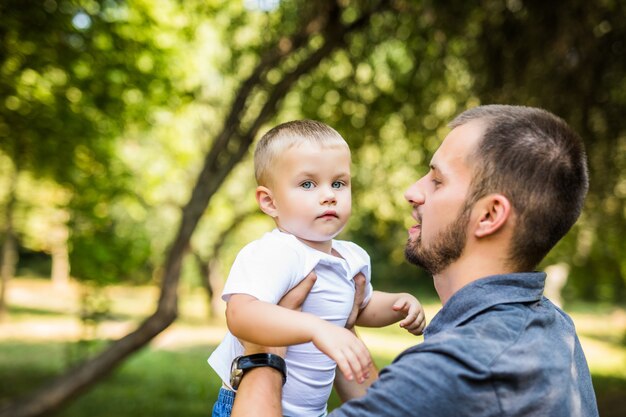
[356,291,426,334]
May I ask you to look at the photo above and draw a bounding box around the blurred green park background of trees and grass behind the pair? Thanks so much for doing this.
[0,0,626,416]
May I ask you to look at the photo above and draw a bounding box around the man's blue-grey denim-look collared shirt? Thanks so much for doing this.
[331,272,598,417]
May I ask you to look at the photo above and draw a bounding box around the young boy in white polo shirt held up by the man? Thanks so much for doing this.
[209,120,425,417]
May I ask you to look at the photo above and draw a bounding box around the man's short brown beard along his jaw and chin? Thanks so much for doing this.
[404,206,471,275]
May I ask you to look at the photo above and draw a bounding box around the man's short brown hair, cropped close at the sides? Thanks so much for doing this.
[450,105,589,271]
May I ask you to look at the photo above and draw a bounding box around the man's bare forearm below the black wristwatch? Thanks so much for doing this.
[231,366,283,417]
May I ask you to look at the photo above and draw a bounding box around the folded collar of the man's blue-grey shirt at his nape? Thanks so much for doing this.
[424,272,546,337]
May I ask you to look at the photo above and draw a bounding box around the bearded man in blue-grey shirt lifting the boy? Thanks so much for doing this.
[228,105,598,417]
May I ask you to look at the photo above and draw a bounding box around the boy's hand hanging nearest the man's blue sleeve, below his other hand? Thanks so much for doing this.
[312,322,372,383]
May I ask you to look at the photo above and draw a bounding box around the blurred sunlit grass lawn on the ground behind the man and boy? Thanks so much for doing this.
[0,279,626,417]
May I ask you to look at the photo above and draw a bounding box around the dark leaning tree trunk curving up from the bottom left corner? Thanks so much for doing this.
[0,0,387,417]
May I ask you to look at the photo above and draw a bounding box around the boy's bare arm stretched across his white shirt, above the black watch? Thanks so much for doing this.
[226,294,371,381]
